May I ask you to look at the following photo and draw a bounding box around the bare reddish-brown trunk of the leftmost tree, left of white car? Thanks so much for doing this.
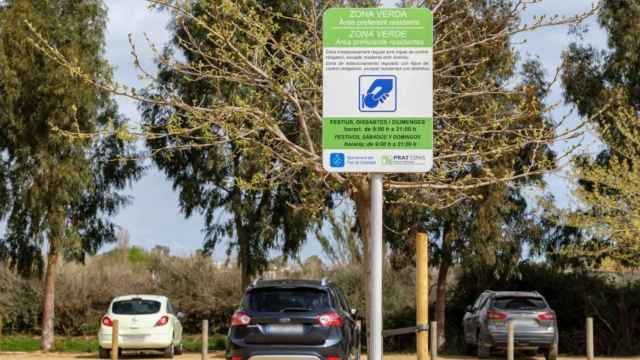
[40,244,60,351]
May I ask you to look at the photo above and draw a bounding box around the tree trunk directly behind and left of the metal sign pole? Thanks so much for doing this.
[352,176,372,349]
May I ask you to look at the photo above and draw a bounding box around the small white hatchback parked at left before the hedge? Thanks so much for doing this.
[98,295,183,359]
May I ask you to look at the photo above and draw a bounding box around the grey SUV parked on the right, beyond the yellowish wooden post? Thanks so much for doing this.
[462,290,558,360]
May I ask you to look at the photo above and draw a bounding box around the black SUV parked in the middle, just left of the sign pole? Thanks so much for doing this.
[226,280,360,360]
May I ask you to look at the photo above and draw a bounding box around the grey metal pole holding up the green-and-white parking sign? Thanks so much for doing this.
[368,174,384,360]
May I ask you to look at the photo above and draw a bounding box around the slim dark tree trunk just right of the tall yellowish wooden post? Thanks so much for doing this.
[436,223,452,351]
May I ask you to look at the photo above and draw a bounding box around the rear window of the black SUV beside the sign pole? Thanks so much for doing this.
[244,288,331,312]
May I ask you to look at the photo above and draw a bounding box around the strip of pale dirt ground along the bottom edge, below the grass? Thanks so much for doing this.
[0,352,640,360]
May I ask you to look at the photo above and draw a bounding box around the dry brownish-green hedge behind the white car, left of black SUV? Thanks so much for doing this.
[0,250,242,336]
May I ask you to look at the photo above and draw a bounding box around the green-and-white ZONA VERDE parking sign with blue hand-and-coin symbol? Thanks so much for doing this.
[322,8,433,173]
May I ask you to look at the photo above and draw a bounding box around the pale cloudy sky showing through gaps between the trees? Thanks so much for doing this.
[105,0,606,259]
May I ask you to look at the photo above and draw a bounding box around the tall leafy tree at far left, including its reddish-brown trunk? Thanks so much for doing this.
[0,0,141,350]
